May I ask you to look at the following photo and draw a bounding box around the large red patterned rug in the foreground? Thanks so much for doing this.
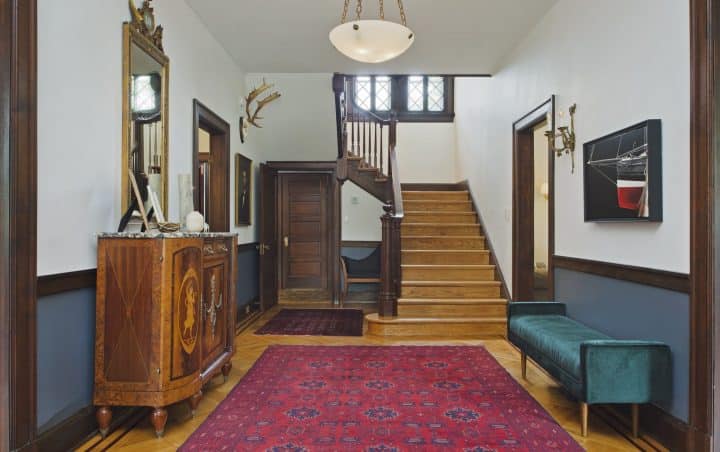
[180,346,582,452]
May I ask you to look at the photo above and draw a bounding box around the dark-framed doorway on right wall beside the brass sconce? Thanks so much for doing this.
[512,96,555,301]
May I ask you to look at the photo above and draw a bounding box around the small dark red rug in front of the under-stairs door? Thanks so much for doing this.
[255,309,363,336]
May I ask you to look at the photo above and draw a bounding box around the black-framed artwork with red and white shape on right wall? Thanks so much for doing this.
[583,119,662,222]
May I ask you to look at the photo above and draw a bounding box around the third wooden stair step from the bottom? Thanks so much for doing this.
[402,281,501,299]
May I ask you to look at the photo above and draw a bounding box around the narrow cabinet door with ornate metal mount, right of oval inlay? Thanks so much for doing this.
[202,260,232,369]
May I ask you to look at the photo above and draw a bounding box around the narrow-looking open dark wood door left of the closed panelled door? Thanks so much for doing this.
[260,164,278,311]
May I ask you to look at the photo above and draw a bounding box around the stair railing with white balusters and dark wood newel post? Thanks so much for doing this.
[333,74,404,317]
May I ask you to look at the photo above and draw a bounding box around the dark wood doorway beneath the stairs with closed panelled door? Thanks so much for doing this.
[259,162,340,310]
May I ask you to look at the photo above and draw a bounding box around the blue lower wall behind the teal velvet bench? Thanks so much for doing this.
[555,268,690,422]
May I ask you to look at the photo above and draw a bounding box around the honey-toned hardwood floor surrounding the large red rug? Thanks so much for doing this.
[79,305,662,452]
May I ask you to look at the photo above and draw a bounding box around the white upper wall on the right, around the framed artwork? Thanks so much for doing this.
[456,0,690,292]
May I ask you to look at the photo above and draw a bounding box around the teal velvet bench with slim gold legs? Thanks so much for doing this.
[508,302,672,436]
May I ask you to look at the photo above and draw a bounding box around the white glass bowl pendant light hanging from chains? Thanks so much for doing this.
[330,0,415,63]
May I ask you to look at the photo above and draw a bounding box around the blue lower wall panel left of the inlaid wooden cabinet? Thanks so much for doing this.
[37,288,95,433]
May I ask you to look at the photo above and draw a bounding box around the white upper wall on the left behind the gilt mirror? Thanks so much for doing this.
[38,0,257,275]
